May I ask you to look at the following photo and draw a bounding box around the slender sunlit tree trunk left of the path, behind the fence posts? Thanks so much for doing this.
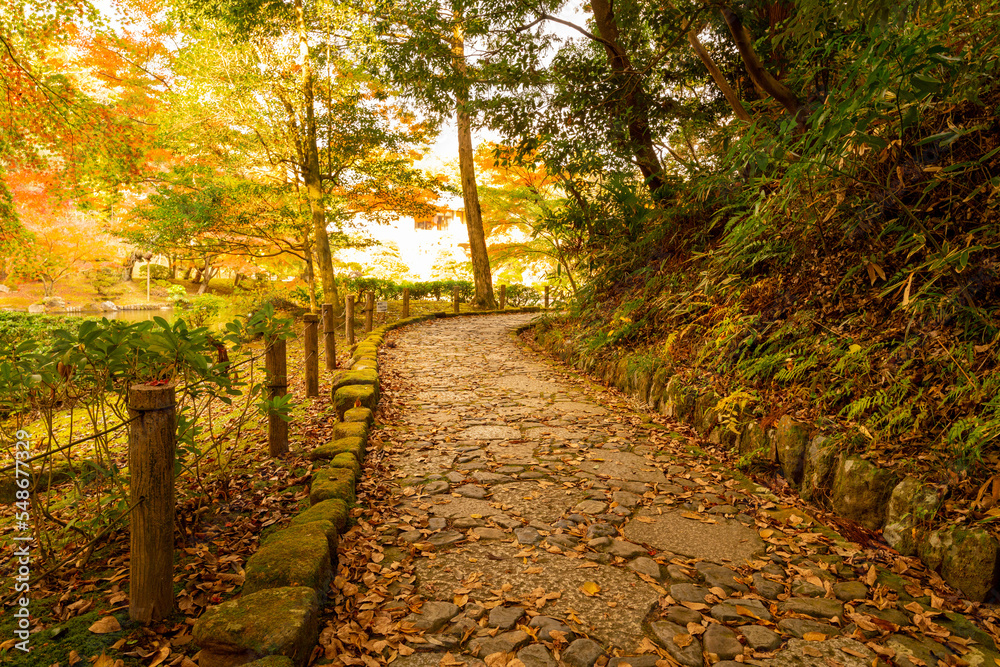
[295,0,340,313]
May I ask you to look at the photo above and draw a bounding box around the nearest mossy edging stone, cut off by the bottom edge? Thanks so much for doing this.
[192,586,319,667]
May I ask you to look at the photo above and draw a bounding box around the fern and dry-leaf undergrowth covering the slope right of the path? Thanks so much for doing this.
[567,7,1000,523]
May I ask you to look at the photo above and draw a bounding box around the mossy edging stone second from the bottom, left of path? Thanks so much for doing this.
[243,522,333,596]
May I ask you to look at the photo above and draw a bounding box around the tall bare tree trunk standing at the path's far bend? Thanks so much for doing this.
[452,14,497,310]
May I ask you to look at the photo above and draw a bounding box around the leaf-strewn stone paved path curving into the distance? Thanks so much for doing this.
[383,315,1000,667]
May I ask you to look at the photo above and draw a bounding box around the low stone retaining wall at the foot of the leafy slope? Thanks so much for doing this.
[521,325,1000,601]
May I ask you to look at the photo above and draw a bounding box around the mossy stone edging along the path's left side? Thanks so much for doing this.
[193,308,540,667]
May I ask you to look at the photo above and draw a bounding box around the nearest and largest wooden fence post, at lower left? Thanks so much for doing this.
[128,384,177,623]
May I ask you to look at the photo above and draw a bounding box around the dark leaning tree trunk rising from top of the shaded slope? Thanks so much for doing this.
[590,0,665,196]
